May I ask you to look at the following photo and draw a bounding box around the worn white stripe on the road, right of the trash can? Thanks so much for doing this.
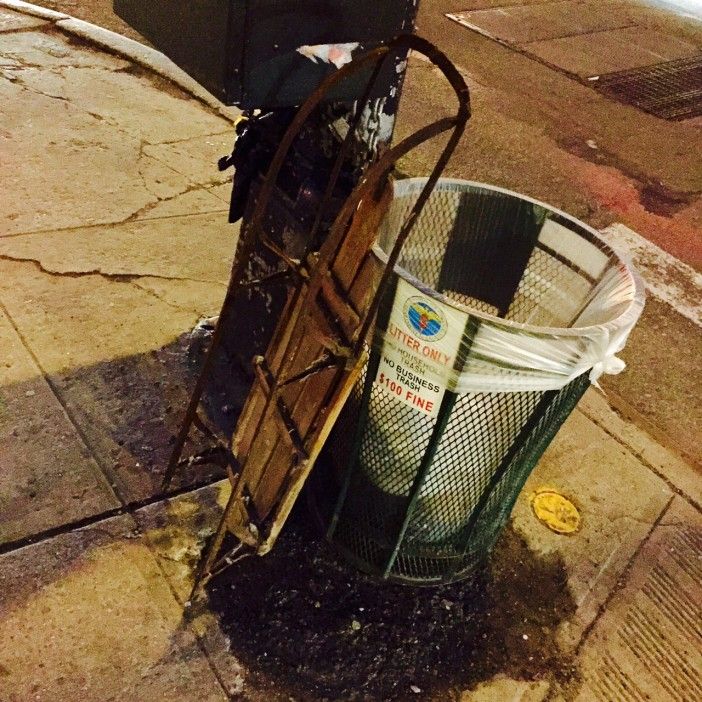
[601,223,702,326]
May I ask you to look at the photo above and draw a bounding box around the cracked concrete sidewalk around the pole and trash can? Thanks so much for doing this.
[0,2,702,702]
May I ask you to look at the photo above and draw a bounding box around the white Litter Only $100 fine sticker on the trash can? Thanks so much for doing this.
[375,279,467,417]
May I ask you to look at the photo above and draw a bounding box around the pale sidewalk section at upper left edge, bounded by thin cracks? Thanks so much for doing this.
[0,78,158,235]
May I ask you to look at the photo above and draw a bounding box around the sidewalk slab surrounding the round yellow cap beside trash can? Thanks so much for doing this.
[512,404,673,649]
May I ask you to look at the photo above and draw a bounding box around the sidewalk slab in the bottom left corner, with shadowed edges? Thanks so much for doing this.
[0,516,229,702]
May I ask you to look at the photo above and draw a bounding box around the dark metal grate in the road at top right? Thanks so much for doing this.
[593,54,702,120]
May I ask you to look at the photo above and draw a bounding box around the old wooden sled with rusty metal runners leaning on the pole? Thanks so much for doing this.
[186,36,470,594]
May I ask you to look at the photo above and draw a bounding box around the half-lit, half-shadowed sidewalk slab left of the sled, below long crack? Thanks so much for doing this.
[0,256,225,502]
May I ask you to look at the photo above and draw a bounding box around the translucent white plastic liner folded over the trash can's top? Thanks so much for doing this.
[374,178,644,404]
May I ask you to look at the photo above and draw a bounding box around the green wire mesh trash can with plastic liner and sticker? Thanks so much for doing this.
[311,178,644,584]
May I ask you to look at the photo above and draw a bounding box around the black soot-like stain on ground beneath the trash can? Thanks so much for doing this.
[208,509,574,702]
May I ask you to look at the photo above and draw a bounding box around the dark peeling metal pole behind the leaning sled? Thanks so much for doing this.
[162,8,419,490]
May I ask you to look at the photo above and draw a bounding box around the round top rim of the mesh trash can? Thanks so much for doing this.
[372,177,645,337]
